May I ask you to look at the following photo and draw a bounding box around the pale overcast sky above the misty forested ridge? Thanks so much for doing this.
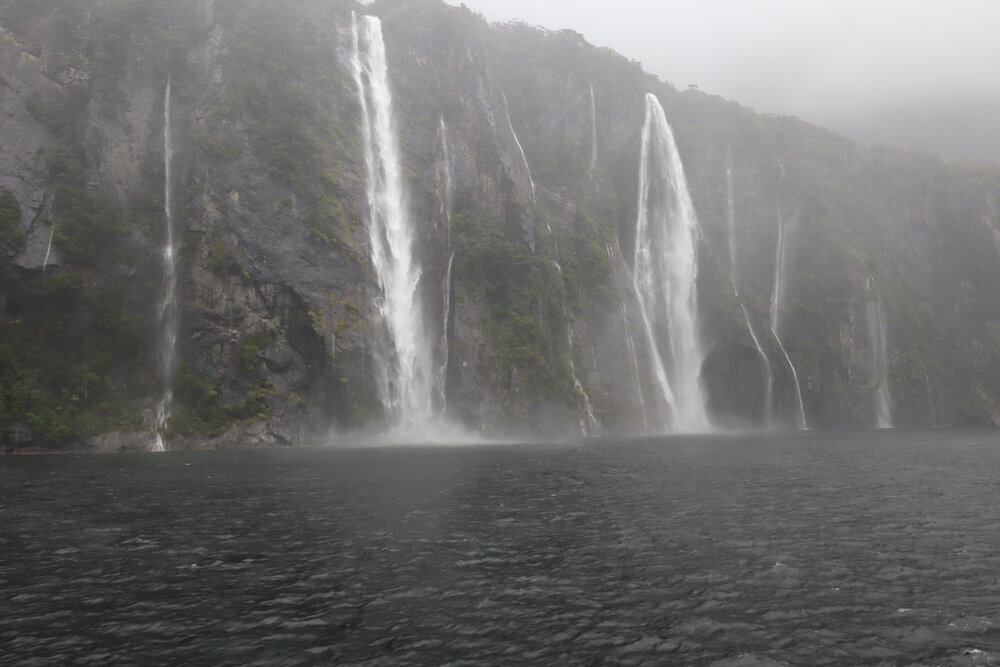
[449,0,1000,122]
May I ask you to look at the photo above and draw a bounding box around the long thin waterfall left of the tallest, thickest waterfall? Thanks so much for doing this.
[153,79,180,452]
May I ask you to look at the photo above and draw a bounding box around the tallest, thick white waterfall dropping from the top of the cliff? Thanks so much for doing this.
[351,13,434,435]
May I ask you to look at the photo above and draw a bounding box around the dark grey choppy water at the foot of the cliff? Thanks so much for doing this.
[0,431,1000,665]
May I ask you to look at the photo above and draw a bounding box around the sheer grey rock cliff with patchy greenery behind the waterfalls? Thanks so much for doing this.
[0,0,1000,450]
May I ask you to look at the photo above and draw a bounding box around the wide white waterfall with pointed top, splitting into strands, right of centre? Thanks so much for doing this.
[632,93,711,432]
